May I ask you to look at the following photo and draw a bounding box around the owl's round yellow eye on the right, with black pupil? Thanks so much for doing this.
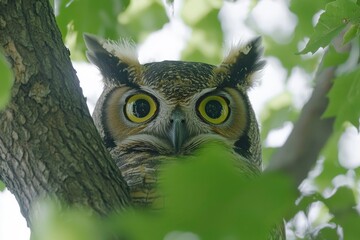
[198,95,230,124]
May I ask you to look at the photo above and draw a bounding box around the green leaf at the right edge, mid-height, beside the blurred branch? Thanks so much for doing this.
[324,67,360,129]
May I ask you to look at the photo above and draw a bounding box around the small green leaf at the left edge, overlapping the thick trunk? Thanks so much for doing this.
[0,53,13,110]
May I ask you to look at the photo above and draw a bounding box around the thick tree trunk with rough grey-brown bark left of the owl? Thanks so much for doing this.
[0,0,129,225]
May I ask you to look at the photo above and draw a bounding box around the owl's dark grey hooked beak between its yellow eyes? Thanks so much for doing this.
[169,109,189,153]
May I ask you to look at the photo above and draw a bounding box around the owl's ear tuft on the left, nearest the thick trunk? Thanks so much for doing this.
[84,34,141,85]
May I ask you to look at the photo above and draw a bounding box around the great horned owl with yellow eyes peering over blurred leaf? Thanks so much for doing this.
[85,35,264,206]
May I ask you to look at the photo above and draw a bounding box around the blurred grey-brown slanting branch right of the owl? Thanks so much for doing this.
[266,31,351,186]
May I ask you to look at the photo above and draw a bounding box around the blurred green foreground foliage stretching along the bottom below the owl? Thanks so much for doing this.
[32,144,360,240]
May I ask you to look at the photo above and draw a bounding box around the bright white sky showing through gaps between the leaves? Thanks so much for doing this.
[0,0,360,240]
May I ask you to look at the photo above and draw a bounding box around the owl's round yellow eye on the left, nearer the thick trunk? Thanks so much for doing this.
[125,93,157,123]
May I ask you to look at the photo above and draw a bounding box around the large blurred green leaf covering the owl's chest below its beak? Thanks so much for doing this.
[115,143,296,240]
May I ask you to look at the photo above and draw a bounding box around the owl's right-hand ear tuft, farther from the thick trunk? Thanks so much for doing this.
[217,37,265,90]
